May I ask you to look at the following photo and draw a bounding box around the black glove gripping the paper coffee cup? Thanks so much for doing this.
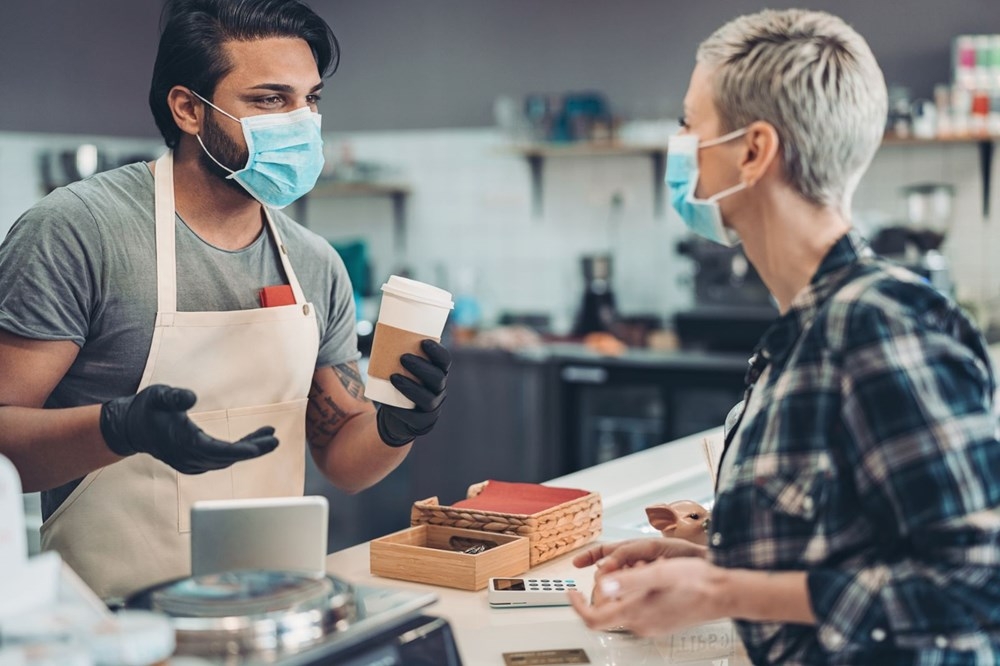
[376,340,451,446]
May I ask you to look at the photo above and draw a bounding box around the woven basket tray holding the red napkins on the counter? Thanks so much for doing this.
[410,481,601,566]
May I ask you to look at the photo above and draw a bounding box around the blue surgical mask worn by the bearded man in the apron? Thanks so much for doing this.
[192,91,323,208]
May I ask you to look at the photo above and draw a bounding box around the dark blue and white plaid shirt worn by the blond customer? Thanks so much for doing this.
[710,234,1000,665]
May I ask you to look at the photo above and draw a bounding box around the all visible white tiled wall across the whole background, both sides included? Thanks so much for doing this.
[0,129,1000,328]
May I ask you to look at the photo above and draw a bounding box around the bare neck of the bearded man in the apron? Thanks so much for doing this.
[159,144,264,250]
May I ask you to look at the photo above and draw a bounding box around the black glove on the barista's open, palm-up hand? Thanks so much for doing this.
[101,384,278,474]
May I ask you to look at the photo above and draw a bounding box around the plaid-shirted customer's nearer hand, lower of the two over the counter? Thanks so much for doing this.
[569,556,726,636]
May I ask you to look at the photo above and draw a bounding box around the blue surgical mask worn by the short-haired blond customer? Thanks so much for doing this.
[666,128,747,247]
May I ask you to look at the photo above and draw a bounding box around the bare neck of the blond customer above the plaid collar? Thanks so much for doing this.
[740,188,850,313]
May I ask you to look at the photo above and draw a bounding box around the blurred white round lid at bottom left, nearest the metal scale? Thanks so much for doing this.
[88,610,176,666]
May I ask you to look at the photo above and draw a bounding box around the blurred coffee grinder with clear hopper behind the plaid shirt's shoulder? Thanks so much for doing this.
[871,183,955,296]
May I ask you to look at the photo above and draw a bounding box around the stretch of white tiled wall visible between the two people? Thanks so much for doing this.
[308,130,689,326]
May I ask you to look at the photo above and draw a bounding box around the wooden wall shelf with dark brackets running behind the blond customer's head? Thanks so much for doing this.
[506,135,1000,219]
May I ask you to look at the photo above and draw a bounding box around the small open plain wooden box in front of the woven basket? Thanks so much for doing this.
[369,525,530,590]
